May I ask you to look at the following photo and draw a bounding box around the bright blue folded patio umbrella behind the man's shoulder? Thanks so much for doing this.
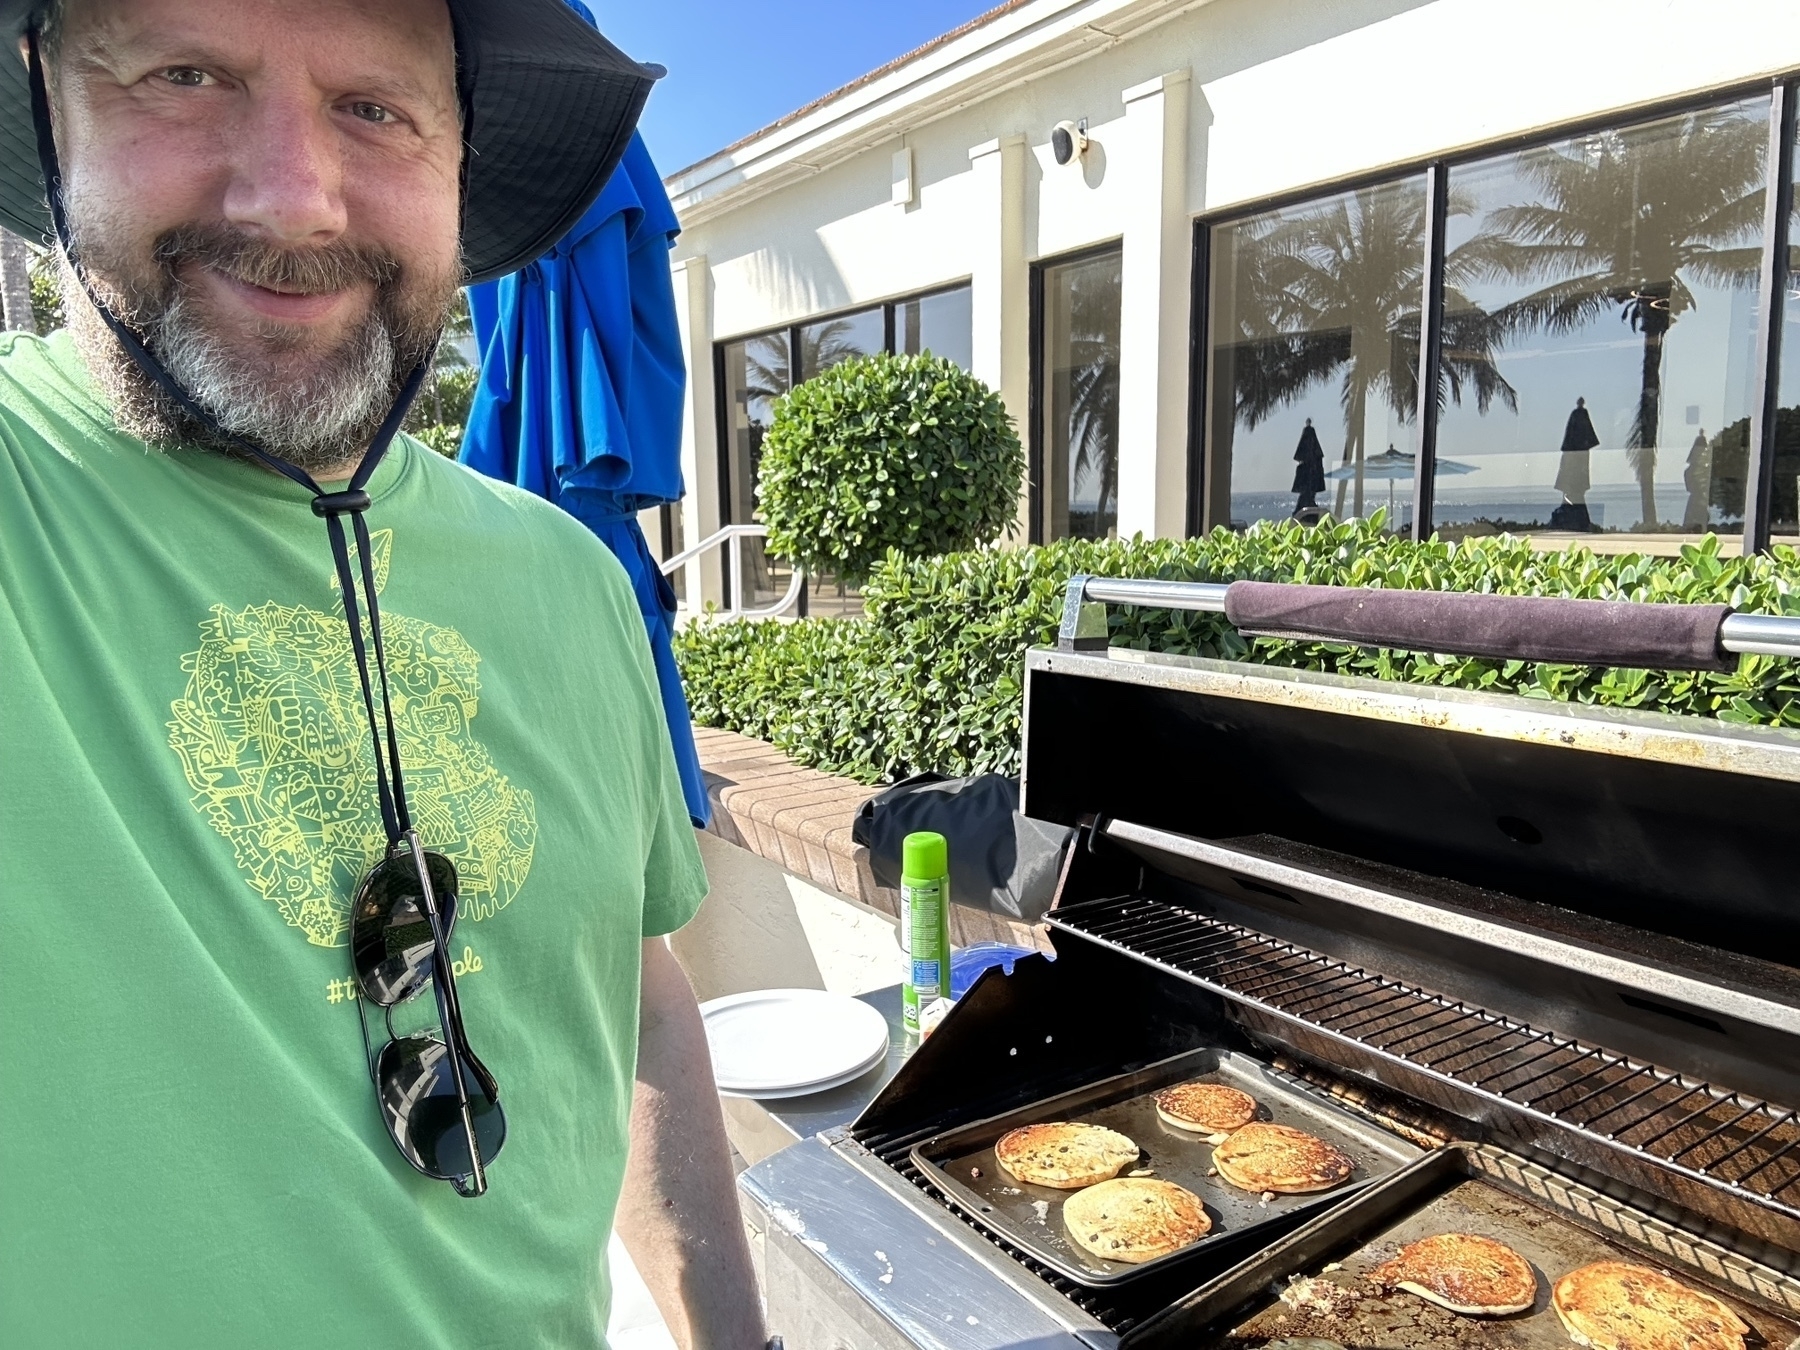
[459,116,709,824]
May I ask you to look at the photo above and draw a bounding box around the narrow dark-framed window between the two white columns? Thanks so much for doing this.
[1031,247,1120,540]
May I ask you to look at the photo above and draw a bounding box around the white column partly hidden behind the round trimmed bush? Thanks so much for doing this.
[968,135,1031,542]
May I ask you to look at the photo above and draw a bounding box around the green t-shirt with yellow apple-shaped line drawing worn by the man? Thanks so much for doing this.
[0,335,706,1350]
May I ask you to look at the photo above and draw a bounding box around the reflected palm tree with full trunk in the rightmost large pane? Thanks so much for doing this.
[1476,101,1768,527]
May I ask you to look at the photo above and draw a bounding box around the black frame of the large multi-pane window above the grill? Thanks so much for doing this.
[1180,70,1800,554]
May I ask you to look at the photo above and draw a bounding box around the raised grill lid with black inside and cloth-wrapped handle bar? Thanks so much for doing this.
[1024,578,1800,965]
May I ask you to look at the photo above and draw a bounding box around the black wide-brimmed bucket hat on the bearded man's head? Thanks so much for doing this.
[0,0,664,281]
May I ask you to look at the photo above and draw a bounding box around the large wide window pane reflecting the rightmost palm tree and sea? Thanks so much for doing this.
[1433,97,1771,542]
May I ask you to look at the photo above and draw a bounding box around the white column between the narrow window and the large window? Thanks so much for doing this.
[1109,70,1193,538]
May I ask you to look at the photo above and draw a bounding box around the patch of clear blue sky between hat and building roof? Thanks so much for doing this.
[589,0,997,173]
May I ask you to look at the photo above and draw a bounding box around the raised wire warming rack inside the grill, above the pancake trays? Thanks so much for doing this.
[1049,895,1800,1213]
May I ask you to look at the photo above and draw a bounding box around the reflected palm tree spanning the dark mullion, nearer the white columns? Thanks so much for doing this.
[1213,180,1517,517]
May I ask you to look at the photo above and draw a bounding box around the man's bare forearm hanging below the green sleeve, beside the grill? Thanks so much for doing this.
[617,938,765,1350]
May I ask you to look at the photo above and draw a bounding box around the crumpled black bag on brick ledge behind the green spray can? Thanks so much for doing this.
[850,774,1073,923]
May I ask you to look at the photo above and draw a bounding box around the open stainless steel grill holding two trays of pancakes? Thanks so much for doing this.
[745,581,1800,1350]
